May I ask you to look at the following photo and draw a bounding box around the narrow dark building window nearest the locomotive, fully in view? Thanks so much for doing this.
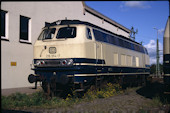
[20,16,30,42]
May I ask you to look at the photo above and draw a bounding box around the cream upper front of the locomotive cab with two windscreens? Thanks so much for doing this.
[34,25,92,59]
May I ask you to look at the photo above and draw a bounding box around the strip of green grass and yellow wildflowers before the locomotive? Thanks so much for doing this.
[1,83,123,109]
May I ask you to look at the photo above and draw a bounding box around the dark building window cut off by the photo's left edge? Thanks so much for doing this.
[1,10,8,39]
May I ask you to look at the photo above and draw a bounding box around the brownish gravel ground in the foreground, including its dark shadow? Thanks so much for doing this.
[2,83,170,113]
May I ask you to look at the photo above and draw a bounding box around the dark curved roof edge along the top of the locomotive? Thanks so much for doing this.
[45,20,142,46]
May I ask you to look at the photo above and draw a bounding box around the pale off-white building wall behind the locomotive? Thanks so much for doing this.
[1,1,128,89]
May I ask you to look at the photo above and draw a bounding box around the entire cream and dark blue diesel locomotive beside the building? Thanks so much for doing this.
[28,20,150,94]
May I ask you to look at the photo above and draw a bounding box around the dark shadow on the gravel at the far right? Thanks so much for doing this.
[136,81,170,104]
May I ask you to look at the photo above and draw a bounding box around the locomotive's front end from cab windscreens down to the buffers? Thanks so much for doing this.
[28,20,95,92]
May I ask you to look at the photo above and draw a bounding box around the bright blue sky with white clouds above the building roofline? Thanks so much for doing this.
[85,1,169,64]
